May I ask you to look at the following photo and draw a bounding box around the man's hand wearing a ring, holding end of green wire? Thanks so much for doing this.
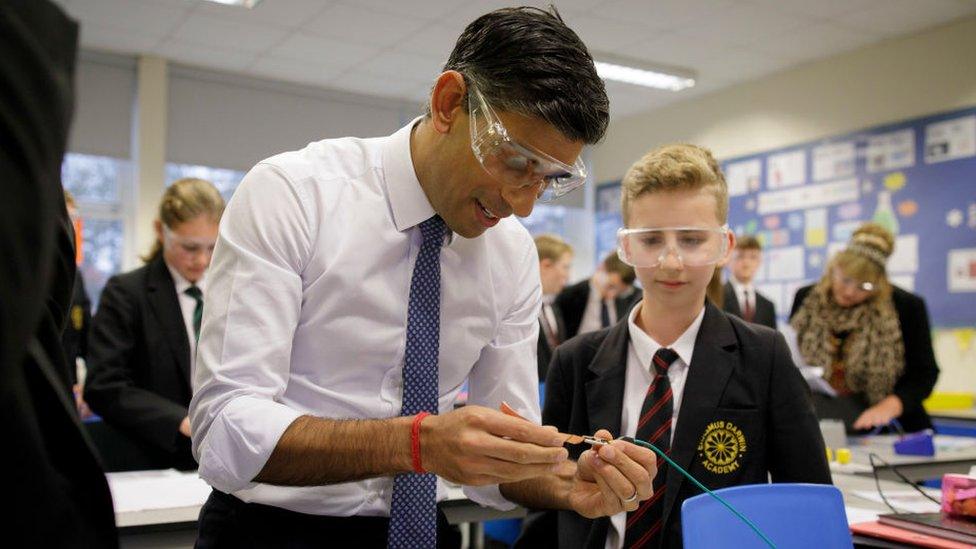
[569,430,657,518]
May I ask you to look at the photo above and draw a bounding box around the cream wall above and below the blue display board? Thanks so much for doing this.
[593,18,976,392]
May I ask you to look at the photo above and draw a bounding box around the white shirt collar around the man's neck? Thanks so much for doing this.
[383,116,436,232]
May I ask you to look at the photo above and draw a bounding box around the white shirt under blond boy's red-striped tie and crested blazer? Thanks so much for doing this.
[606,303,705,549]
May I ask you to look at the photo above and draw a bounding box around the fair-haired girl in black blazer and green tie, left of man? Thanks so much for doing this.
[85,179,224,469]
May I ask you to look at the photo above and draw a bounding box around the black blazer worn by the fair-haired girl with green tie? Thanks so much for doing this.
[85,257,196,469]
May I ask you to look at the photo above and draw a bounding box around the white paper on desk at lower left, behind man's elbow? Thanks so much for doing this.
[105,469,211,513]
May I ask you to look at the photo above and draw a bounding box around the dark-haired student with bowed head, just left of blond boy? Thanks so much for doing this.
[555,252,640,338]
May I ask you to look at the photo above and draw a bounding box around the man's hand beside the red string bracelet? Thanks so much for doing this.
[420,406,569,486]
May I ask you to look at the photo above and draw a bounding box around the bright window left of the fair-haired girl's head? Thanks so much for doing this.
[61,153,131,307]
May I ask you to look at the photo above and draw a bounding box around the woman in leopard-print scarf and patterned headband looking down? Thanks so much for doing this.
[790,223,939,431]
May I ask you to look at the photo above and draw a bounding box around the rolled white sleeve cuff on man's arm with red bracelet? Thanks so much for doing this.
[199,396,302,493]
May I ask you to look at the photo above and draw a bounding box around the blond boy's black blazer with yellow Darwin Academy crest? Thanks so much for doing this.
[522,303,831,549]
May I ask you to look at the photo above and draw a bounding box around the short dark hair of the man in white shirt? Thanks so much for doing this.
[444,6,610,144]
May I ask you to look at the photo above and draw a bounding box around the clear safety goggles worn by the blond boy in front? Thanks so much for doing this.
[617,225,729,268]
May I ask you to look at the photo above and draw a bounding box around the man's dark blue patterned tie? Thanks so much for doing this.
[389,215,444,549]
